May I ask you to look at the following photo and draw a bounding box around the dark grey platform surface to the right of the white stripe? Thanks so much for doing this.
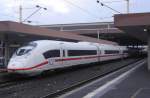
[100,60,150,98]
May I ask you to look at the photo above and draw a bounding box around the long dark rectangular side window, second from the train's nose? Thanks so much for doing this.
[68,50,97,56]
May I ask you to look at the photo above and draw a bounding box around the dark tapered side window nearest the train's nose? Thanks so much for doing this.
[43,50,60,59]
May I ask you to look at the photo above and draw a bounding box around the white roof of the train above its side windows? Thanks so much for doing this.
[33,40,126,50]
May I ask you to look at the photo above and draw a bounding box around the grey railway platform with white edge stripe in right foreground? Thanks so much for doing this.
[60,59,150,98]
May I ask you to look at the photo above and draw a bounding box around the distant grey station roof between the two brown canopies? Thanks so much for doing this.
[41,22,147,46]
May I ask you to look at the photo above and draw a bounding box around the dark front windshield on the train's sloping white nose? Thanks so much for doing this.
[15,43,37,56]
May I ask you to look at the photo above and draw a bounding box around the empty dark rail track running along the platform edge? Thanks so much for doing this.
[40,60,144,98]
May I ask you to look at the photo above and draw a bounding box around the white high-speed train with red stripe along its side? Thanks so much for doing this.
[7,40,128,74]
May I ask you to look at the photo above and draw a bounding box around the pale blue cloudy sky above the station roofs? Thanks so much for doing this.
[0,0,150,25]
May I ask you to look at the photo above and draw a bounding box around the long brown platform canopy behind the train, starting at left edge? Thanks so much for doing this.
[0,21,117,45]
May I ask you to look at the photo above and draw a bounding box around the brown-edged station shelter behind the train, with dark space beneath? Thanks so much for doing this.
[0,21,117,67]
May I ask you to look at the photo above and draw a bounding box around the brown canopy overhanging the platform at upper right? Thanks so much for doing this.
[114,13,150,42]
